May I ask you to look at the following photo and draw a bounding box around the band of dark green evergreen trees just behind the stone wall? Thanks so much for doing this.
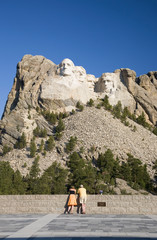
[0,150,157,195]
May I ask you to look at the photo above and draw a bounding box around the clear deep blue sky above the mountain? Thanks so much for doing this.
[0,0,157,119]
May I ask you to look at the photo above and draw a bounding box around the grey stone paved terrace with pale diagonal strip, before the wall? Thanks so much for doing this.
[0,214,157,240]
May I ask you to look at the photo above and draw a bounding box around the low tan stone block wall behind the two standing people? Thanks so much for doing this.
[0,195,157,214]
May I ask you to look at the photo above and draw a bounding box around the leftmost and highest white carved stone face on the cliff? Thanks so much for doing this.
[57,58,75,76]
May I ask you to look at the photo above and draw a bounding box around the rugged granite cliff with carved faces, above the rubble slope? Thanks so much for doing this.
[0,55,157,148]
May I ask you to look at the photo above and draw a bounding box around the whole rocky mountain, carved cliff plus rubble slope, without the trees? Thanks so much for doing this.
[0,55,157,184]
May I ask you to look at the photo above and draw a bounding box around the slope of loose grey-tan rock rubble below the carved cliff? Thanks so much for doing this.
[1,107,157,176]
